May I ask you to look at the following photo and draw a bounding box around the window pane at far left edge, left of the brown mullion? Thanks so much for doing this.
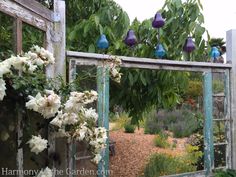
[0,12,13,60]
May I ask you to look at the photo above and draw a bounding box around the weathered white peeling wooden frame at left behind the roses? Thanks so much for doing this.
[0,0,65,177]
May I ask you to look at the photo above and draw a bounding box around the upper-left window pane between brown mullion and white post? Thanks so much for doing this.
[22,23,45,52]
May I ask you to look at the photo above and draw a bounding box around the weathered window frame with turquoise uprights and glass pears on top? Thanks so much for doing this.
[67,51,232,176]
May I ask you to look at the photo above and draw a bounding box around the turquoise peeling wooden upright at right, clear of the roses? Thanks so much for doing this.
[203,70,214,175]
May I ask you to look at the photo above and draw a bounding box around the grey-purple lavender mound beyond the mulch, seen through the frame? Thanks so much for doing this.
[145,109,203,138]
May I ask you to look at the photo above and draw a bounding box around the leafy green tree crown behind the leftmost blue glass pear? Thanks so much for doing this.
[66,0,130,52]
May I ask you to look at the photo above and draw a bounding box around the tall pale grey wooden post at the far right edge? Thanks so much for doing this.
[226,29,236,170]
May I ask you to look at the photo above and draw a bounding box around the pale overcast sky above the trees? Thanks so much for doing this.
[112,0,236,38]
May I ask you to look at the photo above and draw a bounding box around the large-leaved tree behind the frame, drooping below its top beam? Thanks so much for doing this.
[110,0,207,123]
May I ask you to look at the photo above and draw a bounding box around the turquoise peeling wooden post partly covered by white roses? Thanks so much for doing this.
[97,66,109,177]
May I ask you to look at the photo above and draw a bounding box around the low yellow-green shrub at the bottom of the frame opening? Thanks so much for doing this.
[144,154,196,177]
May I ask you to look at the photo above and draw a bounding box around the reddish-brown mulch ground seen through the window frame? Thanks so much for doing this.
[110,129,186,177]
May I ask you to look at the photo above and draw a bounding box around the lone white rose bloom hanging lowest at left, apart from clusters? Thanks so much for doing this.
[27,135,48,154]
